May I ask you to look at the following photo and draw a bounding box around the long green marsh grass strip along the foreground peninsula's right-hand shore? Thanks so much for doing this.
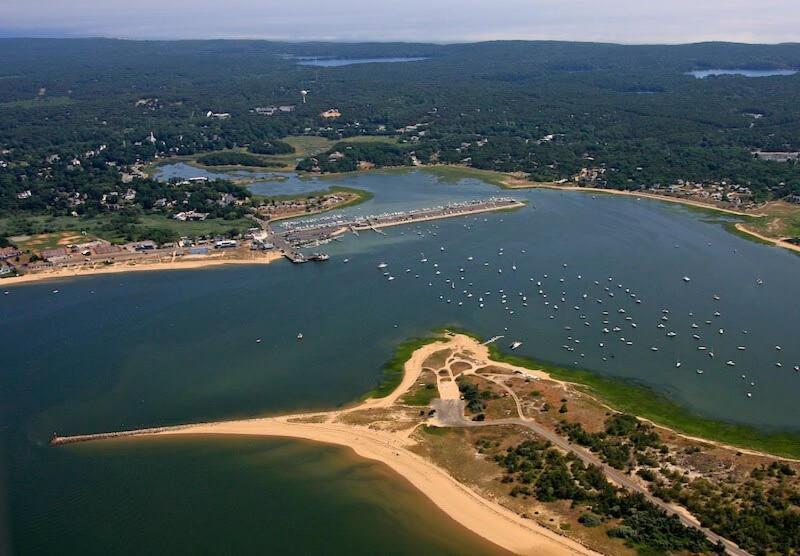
[440,330,800,458]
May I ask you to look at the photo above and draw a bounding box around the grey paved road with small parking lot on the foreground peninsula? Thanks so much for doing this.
[433,382,750,556]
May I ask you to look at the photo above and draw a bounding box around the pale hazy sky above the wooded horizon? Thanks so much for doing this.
[0,0,800,43]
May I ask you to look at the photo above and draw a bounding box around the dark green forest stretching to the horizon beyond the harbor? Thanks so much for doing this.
[0,39,800,241]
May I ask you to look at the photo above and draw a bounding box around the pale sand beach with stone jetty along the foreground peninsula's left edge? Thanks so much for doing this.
[50,336,599,556]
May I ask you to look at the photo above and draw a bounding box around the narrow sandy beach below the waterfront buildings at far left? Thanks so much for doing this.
[0,252,282,288]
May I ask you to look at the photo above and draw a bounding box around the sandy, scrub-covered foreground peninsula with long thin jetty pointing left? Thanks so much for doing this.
[51,333,800,556]
